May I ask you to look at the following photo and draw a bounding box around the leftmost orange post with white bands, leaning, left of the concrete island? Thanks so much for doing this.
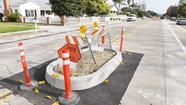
[18,42,31,86]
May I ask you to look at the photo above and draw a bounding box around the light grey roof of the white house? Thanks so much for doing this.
[10,0,51,10]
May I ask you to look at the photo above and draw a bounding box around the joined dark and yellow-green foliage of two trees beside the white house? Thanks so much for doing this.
[49,0,110,16]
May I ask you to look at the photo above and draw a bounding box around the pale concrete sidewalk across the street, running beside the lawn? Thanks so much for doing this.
[0,22,120,45]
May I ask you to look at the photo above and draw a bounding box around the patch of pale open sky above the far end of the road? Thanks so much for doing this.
[136,0,179,14]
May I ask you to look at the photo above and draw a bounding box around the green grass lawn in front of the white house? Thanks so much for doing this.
[0,22,34,33]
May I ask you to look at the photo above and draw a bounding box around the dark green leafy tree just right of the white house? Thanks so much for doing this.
[49,0,82,17]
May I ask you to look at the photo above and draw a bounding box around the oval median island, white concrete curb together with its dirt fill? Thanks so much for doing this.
[45,50,122,90]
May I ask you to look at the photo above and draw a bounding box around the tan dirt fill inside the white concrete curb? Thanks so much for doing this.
[54,50,115,77]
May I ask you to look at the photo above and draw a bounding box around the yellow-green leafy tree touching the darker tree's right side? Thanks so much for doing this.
[82,0,110,16]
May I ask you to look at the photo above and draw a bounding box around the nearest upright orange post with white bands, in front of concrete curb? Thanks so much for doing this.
[62,49,72,99]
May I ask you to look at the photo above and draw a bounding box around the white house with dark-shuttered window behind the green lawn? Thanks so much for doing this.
[0,0,54,21]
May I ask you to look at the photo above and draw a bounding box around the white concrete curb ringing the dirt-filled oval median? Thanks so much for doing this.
[45,52,122,90]
